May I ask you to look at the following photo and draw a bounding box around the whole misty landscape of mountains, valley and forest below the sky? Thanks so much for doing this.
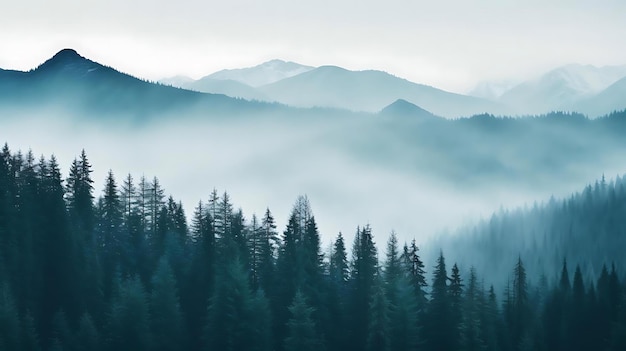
[0,49,626,351]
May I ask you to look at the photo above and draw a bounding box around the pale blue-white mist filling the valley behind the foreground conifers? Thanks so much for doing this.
[0,111,624,253]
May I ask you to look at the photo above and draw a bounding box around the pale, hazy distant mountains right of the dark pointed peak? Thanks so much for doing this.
[161,60,626,118]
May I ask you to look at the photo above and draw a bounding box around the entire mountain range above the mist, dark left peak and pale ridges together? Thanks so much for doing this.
[0,49,626,118]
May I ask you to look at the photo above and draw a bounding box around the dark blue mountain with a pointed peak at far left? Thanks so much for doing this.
[0,49,272,117]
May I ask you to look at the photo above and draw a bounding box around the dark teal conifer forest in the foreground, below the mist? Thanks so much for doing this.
[0,145,626,351]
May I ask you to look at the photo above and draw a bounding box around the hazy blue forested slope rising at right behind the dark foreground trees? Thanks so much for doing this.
[435,172,626,290]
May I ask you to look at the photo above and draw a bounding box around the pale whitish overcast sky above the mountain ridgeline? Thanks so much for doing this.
[0,0,626,92]
